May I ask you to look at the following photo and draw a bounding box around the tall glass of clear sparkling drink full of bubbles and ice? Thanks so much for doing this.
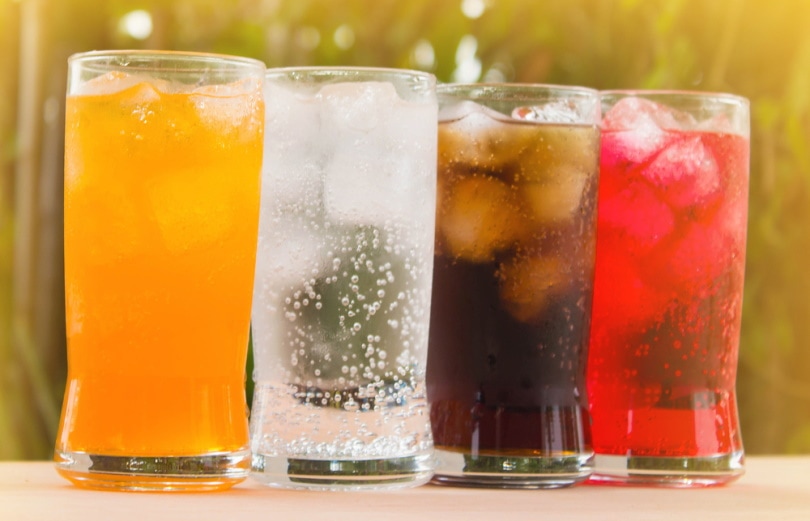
[251,68,437,490]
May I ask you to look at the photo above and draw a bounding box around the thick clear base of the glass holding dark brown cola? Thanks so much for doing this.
[433,450,593,489]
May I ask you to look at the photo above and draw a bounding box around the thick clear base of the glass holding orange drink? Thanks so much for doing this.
[54,450,250,492]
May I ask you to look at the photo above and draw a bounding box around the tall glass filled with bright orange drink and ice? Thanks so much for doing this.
[55,51,265,490]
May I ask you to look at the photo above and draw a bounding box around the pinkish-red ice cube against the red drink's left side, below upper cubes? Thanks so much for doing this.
[599,181,675,255]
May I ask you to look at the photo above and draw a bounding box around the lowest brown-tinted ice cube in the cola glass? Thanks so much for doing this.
[498,255,570,322]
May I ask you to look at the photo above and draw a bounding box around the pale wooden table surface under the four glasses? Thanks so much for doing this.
[0,456,810,521]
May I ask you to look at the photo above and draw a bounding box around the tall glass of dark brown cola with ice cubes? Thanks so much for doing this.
[427,84,600,488]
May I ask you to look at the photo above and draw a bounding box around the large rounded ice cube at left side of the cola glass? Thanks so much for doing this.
[437,176,531,262]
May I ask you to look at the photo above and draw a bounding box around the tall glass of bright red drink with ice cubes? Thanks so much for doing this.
[588,91,749,486]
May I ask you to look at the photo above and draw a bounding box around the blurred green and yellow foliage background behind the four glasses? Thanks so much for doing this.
[0,0,810,460]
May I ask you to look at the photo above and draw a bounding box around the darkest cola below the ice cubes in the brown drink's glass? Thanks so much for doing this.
[427,257,590,454]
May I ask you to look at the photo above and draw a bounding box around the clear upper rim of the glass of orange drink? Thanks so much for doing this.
[67,49,267,72]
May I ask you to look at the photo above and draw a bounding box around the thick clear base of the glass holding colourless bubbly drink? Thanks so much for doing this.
[251,448,435,491]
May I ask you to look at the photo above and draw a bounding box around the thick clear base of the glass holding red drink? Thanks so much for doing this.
[590,451,745,488]
